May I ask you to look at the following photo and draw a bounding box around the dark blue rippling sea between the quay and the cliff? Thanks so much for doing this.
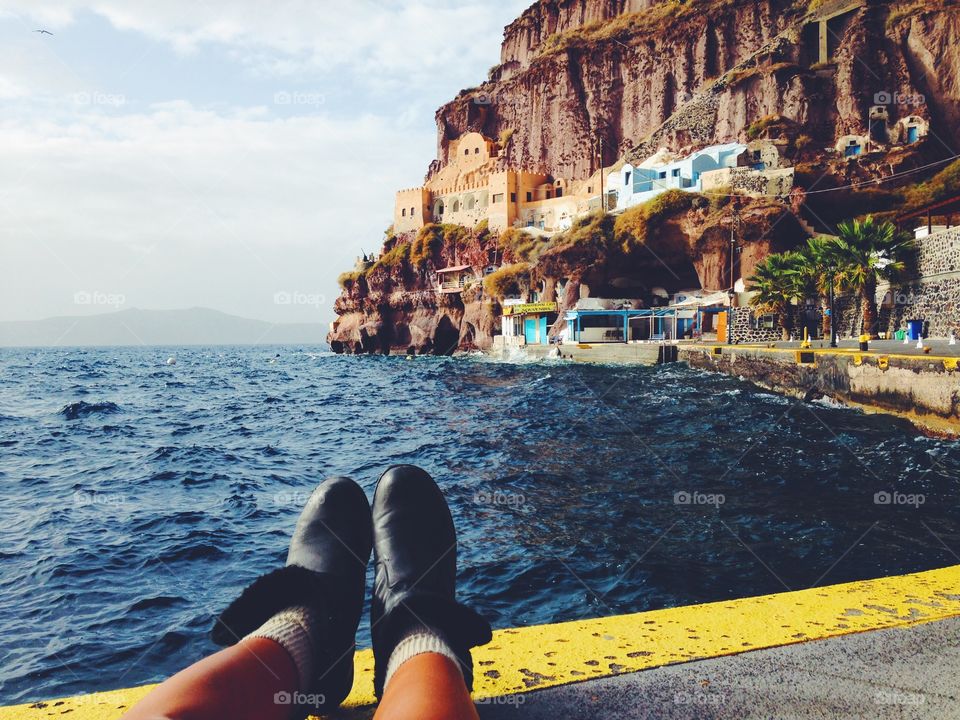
[0,347,960,704]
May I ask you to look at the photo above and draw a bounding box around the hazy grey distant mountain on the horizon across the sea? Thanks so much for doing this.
[0,308,328,347]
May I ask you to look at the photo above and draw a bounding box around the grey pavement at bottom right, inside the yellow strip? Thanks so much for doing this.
[479,618,960,720]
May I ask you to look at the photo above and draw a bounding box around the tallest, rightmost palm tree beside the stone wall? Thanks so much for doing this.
[836,215,914,338]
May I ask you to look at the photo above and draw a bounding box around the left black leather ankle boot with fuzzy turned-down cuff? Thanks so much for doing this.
[213,477,373,716]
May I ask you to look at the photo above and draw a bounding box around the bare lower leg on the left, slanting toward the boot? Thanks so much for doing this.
[123,638,298,720]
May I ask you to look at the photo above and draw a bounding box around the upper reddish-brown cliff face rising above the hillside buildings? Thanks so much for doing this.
[431,0,960,178]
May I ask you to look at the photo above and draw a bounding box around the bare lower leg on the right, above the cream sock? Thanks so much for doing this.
[374,653,478,720]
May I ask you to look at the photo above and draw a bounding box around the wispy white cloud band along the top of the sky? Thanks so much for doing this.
[0,0,527,87]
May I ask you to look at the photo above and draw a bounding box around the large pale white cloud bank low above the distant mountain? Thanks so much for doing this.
[0,102,434,321]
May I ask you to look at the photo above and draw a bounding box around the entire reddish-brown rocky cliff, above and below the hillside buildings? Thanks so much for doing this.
[330,0,960,352]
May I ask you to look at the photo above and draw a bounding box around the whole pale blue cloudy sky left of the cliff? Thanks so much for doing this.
[0,0,531,322]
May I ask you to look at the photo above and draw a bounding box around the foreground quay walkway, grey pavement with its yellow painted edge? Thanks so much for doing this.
[0,565,960,720]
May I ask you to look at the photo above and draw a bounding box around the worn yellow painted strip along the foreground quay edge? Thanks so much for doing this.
[0,565,960,720]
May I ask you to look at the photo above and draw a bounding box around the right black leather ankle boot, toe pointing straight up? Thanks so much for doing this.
[370,465,490,697]
